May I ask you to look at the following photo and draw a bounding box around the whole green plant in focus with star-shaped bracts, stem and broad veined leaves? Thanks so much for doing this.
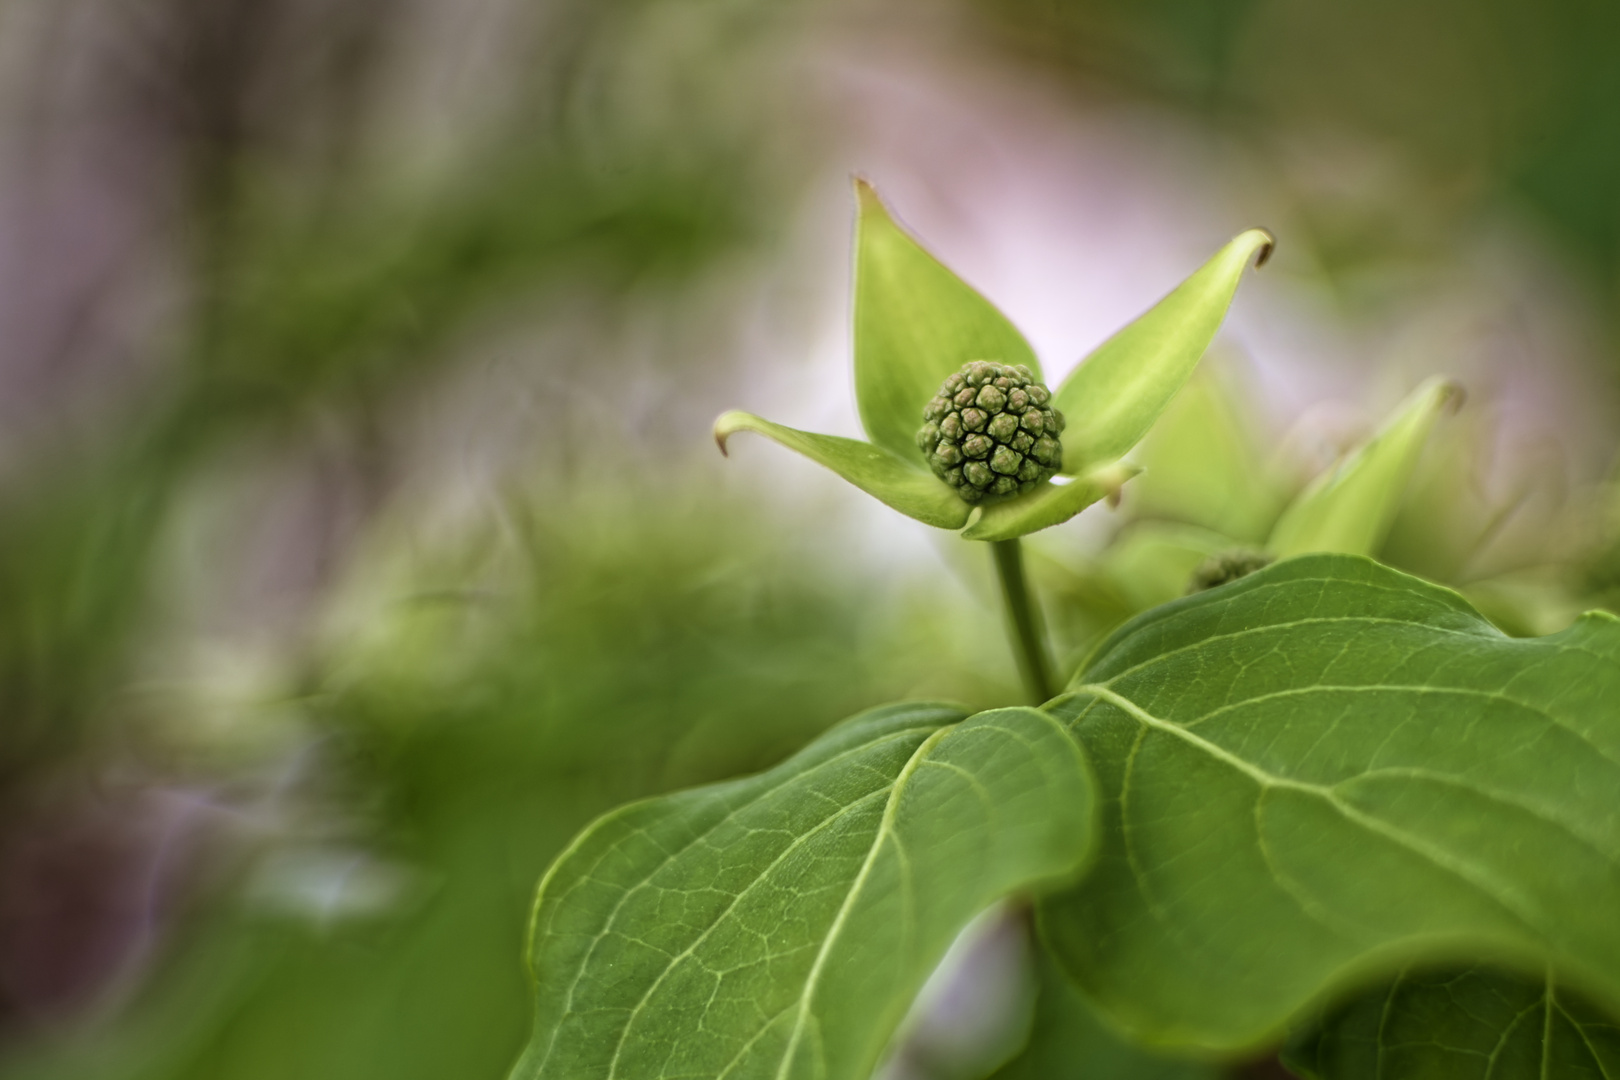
[512,185,1620,1080]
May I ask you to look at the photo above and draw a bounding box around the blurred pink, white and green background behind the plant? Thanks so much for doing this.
[0,0,1620,1080]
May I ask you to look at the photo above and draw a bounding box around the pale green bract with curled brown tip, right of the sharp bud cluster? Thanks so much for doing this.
[1055,228,1273,473]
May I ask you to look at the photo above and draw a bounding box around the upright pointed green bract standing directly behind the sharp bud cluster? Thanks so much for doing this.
[855,180,1040,461]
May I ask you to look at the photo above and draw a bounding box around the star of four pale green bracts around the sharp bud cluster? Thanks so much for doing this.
[714,181,1272,541]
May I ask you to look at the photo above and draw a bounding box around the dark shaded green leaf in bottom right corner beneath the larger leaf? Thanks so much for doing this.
[1286,965,1620,1080]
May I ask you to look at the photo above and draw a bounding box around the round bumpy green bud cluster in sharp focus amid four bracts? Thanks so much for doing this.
[917,359,1063,502]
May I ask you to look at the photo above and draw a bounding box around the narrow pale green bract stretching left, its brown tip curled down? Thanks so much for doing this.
[714,410,972,529]
